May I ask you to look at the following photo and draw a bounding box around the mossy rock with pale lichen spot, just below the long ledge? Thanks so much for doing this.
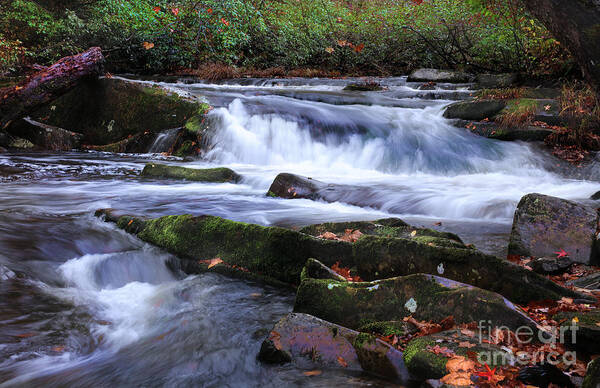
[294,274,538,332]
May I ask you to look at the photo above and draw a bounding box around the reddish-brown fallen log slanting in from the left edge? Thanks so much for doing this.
[0,47,104,129]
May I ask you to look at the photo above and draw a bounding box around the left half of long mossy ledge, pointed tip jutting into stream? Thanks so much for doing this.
[96,210,352,286]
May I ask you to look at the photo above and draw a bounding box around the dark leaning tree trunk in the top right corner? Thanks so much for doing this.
[522,0,600,90]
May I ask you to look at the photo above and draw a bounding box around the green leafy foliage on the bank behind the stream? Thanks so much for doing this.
[0,0,569,74]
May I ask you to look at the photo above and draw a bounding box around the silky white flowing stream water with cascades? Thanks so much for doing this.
[0,78,599,387]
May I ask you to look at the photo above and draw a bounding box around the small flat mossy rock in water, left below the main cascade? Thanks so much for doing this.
[141,163,241,183]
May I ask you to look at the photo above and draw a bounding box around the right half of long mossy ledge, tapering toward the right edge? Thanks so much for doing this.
[352,236,587,304]
